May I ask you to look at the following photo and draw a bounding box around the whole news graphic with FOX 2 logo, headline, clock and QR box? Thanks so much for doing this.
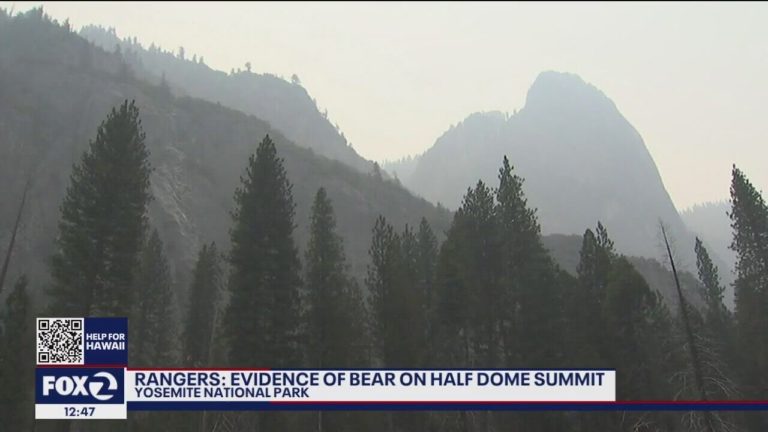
[35,318,616,419]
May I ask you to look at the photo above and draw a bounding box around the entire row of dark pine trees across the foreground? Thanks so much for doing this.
[0,101,768,432]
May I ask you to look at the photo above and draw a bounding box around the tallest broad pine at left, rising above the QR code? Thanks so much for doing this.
[50,101,150,316]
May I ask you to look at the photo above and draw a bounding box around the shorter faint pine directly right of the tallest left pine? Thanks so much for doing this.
[129,230,177,367]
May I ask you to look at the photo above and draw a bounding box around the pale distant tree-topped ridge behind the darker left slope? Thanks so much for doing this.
[80,25,373,173]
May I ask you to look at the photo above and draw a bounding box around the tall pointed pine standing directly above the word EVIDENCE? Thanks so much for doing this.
[224,135,301,367]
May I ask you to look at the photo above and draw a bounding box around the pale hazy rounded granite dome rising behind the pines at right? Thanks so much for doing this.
[408,72,693,258]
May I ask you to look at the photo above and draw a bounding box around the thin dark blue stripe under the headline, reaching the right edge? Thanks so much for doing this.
[128,401,768,411]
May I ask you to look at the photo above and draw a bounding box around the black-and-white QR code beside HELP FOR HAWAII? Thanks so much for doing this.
[37,318,83,365]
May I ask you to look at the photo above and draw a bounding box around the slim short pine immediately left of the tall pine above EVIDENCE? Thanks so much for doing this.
[184,243,223,367]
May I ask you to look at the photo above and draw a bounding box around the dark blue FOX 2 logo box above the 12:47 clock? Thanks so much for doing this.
[35,368,125,404]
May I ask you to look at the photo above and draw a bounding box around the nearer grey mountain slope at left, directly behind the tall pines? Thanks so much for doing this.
[0,11,450,296]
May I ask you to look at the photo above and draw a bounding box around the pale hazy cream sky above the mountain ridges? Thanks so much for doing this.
[6,2,768,209]
